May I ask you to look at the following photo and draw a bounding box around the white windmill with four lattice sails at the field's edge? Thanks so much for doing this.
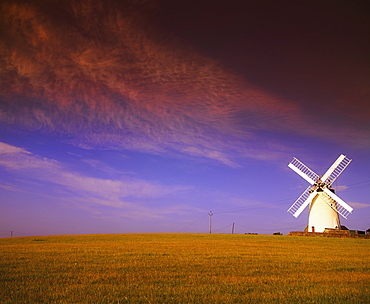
[288,154,353,232]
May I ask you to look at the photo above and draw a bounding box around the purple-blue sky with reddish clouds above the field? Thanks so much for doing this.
[0,0,370,237]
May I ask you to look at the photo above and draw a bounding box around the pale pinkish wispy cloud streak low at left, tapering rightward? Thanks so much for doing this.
[0,143,188,212]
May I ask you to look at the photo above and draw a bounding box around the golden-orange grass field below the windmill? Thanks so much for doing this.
[0,234,370,304]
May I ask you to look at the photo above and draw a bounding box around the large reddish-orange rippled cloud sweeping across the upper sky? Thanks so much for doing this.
[0,0,368,166]
